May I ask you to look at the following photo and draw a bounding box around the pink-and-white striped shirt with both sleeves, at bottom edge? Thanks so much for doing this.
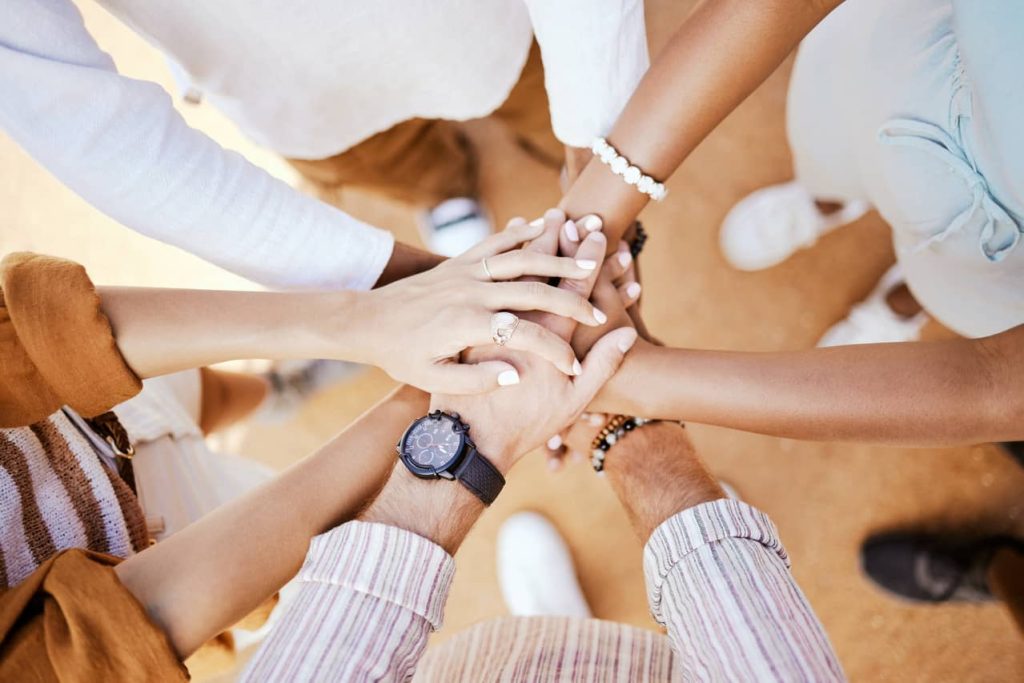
[243,500,844,681]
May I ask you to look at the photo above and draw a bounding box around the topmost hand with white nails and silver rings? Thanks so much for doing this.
[352,218,603,394]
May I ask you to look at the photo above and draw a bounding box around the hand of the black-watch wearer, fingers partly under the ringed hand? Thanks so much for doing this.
[430,212,637,472]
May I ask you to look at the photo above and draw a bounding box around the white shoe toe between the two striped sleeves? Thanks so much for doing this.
[498,512,591,618]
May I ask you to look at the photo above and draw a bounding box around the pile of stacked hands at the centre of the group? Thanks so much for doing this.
[371,209,642,473]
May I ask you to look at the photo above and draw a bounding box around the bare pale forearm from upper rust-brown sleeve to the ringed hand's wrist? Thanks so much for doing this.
[97,288,366,377]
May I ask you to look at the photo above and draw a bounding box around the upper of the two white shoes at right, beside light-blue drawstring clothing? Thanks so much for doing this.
[719,181,869,270]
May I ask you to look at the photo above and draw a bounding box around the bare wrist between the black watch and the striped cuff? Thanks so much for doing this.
[360,464,484,555]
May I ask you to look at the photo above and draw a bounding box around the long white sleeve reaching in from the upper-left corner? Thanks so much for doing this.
[0,0,393,289]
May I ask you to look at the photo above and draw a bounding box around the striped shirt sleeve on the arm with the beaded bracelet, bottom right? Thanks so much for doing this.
[644,500,845,681]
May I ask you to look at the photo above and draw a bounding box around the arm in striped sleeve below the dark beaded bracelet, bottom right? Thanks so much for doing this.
[605,423,844,681]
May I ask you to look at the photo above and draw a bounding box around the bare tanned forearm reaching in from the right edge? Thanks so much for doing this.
[594,328,1024,445]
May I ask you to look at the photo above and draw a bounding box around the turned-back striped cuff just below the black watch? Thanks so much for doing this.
[298,521,455,631]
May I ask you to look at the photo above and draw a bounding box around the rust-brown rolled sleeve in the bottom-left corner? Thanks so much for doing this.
[0,550,188,681]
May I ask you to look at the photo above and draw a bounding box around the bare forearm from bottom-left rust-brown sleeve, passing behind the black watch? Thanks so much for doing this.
[117,387,427,657]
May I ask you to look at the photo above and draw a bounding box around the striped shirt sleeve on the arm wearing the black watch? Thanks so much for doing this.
[242,521,455,682]
